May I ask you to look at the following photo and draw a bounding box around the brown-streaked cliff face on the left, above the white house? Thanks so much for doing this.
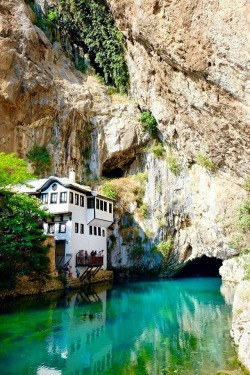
[0,0,143,180]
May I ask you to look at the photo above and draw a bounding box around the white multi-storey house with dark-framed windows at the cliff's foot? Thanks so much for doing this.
[20,170,114,277]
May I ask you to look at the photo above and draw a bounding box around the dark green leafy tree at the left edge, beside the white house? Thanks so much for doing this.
[0,189,49,287]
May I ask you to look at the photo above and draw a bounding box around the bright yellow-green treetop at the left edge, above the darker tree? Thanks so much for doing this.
[0,152,34,187]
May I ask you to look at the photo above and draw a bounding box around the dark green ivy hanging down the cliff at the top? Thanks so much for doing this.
[58,0,129,93]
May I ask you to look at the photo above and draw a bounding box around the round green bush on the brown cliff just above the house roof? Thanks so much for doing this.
[26,144,51,176]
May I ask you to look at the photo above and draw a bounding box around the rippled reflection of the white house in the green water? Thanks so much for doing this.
[46,290,112,375]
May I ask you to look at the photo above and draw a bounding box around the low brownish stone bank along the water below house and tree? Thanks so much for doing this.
[0,270,113,299]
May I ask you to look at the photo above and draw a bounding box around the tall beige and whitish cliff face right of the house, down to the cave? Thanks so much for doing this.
[108,0,250,274]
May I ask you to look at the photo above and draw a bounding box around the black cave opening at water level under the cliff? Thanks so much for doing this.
[176,255,222,278]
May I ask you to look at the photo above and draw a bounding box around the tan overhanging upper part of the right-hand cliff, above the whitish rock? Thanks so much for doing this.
[108,0,250,176]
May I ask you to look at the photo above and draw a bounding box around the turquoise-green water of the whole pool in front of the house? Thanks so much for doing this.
[0,278,241,375]
